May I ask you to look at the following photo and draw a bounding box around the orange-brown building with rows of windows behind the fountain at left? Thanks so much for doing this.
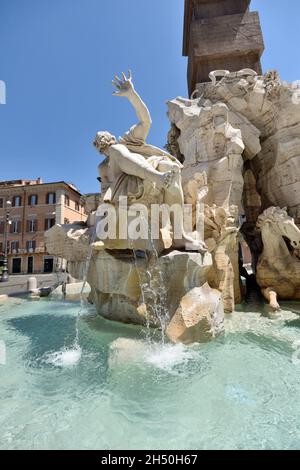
[0,179,87,274]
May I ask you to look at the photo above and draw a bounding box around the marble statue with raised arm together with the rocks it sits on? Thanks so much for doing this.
[46,72,224,343]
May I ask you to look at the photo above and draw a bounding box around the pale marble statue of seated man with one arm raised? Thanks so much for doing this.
[94,72,207,252]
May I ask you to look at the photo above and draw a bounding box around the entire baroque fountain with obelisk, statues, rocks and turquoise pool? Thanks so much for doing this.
[0,0,300,450]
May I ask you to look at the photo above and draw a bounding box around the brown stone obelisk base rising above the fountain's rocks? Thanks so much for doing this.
[183,0,264,94]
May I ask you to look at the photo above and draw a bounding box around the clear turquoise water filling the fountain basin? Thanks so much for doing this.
[0,301,300,450]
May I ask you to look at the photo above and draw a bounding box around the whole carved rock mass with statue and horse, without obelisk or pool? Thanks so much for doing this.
[46,69,300,344]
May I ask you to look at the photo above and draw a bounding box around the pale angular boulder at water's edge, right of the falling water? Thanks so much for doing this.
[167,283,224,344]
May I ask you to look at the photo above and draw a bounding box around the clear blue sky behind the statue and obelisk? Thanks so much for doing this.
[0,0,300,192]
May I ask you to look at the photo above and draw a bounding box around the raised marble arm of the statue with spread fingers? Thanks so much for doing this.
[113,71,152,142]
